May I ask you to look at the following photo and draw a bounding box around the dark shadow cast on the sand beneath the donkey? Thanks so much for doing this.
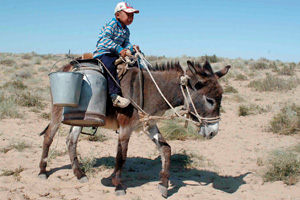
[94,154,250,196]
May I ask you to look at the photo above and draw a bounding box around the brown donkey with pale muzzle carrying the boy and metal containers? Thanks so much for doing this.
[39,61,230,197]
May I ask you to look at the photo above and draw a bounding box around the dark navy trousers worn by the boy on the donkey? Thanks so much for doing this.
[97,53,121,95]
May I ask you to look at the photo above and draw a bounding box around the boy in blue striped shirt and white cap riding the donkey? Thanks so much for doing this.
[93,2,139,108]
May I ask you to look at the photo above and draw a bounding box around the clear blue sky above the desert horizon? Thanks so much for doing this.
[0,0,300,62]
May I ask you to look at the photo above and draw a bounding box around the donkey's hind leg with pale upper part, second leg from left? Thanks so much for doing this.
[66,126,88,183]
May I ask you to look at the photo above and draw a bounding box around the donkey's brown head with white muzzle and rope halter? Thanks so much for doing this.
[186,61,230,139]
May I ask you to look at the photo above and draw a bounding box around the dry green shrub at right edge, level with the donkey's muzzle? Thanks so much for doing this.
[269,104,300,135]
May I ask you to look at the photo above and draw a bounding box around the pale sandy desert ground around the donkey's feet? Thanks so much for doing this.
[0,56,300,200]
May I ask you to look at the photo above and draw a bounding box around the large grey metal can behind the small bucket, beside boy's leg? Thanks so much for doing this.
[62,69,107,127]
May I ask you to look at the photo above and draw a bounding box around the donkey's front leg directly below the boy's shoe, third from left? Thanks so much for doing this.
[111,127,132,196]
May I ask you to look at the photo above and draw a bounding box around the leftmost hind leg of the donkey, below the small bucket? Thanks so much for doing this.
[39,108,62,179]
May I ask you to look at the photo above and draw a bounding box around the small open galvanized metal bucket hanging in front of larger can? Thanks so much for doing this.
[49,72,83,107]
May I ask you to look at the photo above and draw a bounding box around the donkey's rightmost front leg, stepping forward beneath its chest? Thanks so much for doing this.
[148,125,171,198]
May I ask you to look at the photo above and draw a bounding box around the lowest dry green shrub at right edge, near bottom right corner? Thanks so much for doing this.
[263,151,300,185]
